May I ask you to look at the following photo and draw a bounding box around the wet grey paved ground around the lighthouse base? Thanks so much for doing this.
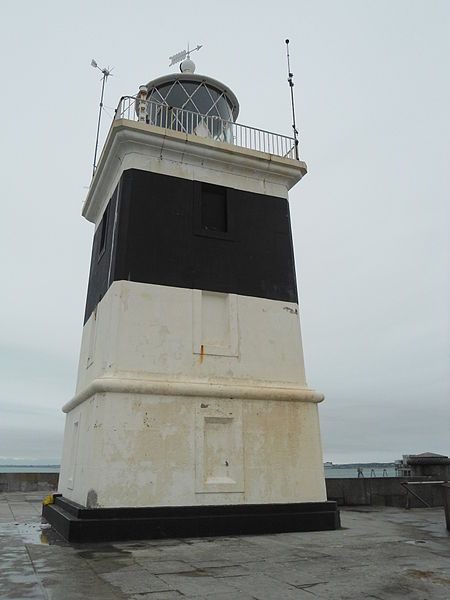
[0,492,450,600]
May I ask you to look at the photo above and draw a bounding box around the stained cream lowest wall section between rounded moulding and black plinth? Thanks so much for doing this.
[59,394,326,507]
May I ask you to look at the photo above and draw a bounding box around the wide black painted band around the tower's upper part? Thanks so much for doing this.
[85,169,297,322]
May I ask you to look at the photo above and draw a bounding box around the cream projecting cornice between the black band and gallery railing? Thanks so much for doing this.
[82,119,306,223]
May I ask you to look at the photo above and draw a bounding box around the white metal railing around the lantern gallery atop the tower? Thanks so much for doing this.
[114,96,298,160]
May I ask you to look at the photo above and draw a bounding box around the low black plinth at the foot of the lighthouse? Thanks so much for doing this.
[42,496,340,542]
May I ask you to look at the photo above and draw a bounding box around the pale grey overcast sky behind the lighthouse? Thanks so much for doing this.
[0,0,450,462]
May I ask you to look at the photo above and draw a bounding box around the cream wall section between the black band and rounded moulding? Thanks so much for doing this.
[77,281,306,393]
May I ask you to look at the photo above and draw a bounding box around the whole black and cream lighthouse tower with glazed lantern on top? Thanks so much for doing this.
[44,58,339,541]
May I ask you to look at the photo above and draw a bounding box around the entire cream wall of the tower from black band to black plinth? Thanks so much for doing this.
[59,281,325,506]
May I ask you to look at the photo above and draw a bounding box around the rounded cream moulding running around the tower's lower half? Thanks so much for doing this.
[62,377,324,413]
